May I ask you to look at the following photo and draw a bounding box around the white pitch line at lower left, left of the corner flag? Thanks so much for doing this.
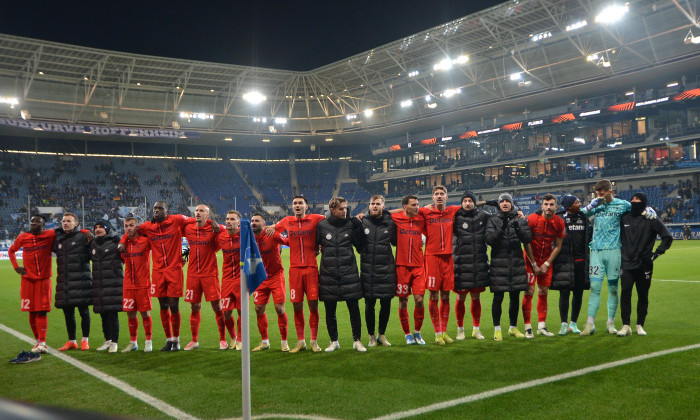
[0,323,197,420]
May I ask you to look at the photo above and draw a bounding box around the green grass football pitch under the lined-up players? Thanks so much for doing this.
[0,241,700,419]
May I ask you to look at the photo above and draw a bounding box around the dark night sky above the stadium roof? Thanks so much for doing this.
[0,0,501,70]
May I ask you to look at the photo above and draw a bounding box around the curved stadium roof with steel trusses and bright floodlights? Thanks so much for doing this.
[0,0,700,144]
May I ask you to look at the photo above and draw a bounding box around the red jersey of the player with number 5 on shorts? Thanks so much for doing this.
[120,214,195,271]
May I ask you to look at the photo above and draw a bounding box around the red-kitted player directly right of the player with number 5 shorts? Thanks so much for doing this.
[182,204,228,351]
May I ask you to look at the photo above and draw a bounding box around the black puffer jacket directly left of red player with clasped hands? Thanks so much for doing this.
[485,210,532,292]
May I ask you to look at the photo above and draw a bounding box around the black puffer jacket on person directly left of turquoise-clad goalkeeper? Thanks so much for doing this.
[549,213,593,290]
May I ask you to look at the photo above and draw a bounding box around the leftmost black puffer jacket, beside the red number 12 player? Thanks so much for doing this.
[53,228,92,308]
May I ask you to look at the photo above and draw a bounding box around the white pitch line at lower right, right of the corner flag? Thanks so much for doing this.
[374,343,700,420]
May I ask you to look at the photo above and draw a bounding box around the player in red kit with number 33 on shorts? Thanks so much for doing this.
[391,195,425,345]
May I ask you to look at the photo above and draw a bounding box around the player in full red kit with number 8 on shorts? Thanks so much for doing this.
[267,195,324,353]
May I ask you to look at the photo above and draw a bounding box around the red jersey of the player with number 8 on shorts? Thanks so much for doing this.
[275,214,325,267]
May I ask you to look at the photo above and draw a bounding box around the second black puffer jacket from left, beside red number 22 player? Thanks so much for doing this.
[90,232,124,313]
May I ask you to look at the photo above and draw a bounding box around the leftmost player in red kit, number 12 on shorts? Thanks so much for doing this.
[7,216,56,353]
